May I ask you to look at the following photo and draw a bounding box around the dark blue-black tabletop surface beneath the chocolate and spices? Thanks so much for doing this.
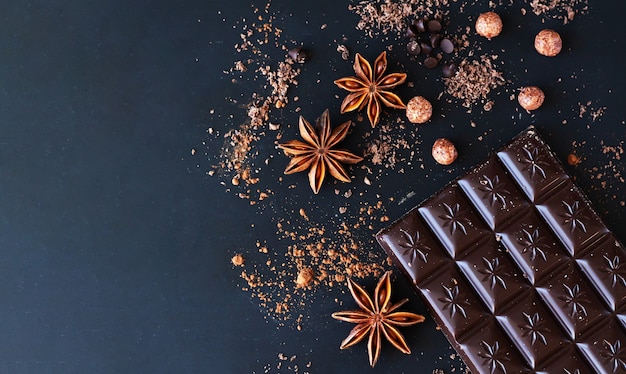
[0,0,626,373]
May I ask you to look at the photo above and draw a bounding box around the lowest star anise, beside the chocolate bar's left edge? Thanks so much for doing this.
[332,271,424,367]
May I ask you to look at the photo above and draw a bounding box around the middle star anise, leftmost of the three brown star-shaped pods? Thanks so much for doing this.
[278,109,363,193]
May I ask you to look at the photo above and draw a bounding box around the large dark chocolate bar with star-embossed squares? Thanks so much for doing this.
[376,129,626,374]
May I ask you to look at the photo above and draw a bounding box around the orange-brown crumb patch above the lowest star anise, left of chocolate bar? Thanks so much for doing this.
[235,201,389,330]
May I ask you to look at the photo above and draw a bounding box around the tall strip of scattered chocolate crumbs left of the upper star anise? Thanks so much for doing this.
[207,3,301,205]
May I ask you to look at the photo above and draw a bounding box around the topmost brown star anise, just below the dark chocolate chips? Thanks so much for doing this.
[335,52,406,127]
